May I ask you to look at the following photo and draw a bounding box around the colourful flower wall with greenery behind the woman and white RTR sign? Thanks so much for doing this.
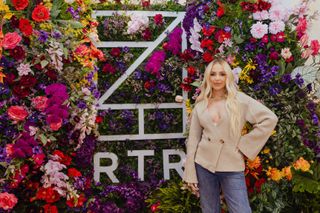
[0,0,320,212]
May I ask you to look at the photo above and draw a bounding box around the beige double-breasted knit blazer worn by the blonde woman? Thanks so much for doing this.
[183,92,278,183]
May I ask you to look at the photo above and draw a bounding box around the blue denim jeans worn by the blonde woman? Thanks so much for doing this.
[196,163,251,213]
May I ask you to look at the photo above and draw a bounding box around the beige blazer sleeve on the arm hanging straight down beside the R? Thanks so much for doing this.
[183,108,202,183]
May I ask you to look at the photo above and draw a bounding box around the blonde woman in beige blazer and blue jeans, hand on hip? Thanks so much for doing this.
[183,59,278,213]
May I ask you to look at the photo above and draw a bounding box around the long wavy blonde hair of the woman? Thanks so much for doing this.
[196,59,241,137]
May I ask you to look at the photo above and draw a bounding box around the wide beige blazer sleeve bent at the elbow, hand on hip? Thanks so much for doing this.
[238,95,278,160]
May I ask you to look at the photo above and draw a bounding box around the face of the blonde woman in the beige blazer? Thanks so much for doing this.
[209,63,227,90]
